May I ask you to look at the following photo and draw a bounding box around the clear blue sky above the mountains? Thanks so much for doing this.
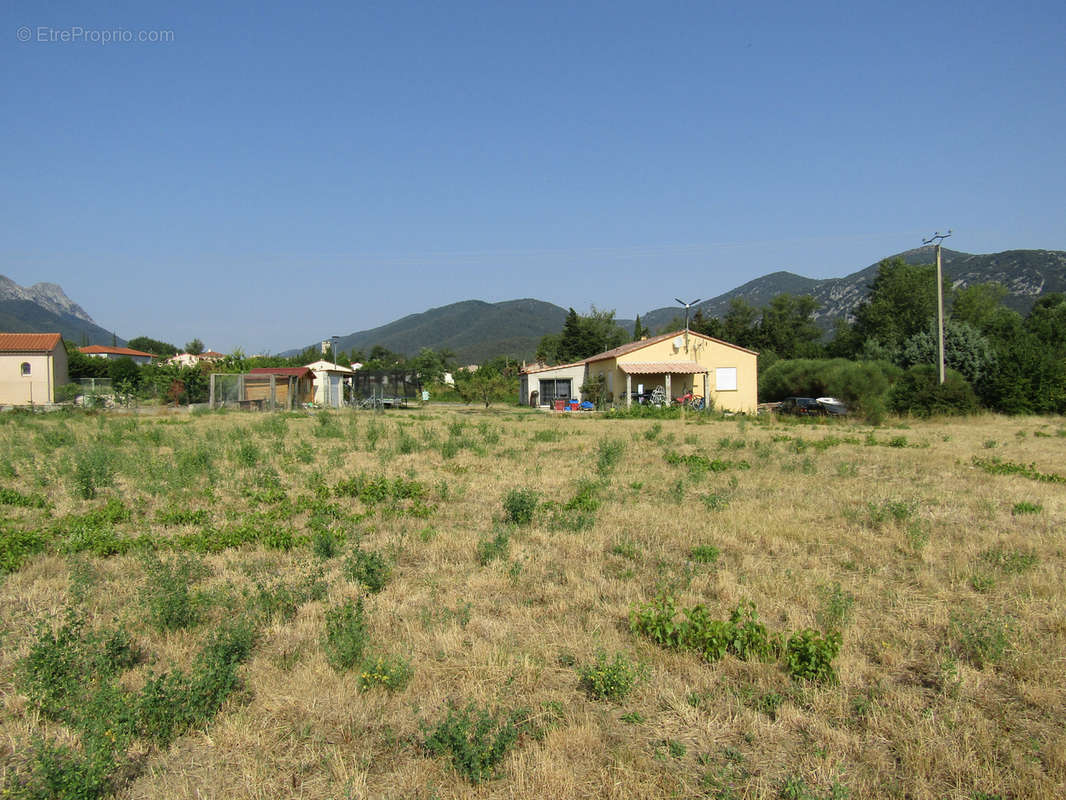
[0,0,1066,353]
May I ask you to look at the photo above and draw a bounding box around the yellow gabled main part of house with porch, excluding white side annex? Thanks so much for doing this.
[585,331,759,414]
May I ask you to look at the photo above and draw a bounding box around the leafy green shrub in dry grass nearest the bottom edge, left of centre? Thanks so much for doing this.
[423,703,518,783]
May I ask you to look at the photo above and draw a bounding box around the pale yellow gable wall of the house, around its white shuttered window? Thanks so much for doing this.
[588,333,758,414]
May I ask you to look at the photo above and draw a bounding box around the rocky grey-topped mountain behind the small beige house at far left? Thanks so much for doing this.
[0,275,126,345]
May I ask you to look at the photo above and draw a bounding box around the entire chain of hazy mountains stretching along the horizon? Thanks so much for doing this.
[0,245,1066,364]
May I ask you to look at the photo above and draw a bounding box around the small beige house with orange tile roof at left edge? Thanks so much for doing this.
[0,333,69,405]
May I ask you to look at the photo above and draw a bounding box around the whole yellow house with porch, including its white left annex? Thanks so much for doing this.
[519,331,758,413]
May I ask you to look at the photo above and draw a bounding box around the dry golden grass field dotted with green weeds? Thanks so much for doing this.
[0,406,1066,800]
